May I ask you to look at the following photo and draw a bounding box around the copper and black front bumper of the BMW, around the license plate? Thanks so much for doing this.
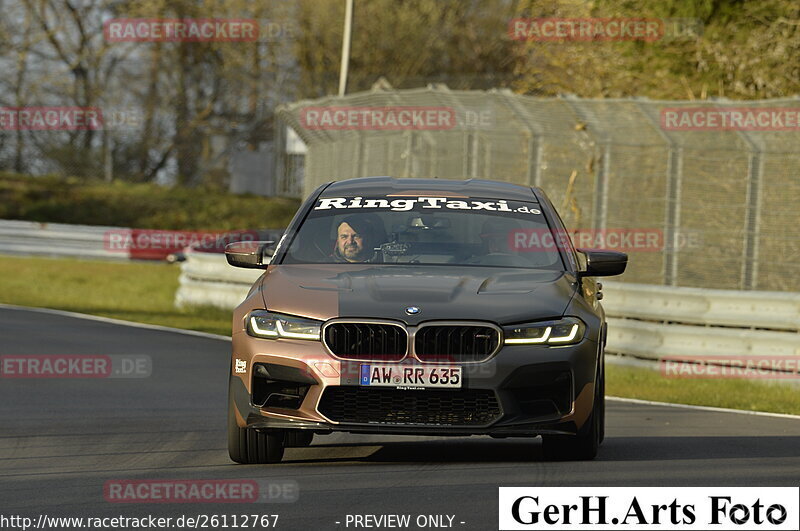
[230,332,599,437]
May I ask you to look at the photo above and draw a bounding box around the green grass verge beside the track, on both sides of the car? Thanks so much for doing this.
[0,256,800,414]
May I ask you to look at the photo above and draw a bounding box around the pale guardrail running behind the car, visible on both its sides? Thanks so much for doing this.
[175,253,800,370]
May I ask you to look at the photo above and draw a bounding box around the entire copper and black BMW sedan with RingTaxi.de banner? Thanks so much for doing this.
[226,177,627,463]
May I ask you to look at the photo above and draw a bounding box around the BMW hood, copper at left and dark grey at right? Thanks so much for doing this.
[261,264,576,325]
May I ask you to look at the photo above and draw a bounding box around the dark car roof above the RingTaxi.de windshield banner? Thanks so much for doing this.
[321,176,539,203]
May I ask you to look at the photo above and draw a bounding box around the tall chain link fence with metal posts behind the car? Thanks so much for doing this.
[276,85,800,291]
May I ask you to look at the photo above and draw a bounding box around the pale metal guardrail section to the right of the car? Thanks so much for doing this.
[603,282,800,363]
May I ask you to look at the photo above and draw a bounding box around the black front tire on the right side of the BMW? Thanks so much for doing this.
[542,353,606,461]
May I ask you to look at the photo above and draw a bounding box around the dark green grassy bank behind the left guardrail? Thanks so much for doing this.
[0,172,300,230]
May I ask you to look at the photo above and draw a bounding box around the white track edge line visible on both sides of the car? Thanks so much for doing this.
[0,303,800,420]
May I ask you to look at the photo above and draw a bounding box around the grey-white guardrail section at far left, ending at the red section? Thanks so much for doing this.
[0,220,130,260]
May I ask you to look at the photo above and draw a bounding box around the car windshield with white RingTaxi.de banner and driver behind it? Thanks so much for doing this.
[281,196,563,271]
